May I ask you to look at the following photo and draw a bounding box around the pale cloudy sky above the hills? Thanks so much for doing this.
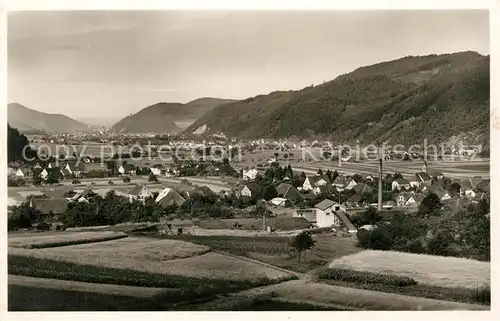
[8,10,490,120]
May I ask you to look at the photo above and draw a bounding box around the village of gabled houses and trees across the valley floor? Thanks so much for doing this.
[8,136,490,232]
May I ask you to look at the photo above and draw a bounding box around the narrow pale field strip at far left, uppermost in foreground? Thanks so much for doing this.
[8,231,127,249]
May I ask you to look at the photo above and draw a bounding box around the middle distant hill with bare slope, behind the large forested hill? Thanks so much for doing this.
[111,97,234,133]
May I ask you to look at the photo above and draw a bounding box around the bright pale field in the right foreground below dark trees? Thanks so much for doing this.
[330,251,490,289]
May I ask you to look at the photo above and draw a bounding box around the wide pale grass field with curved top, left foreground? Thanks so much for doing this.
[9,238,287,280]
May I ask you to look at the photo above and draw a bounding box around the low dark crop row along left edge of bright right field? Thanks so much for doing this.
[317,268,417,287]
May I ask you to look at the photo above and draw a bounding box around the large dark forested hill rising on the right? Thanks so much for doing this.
[184,52,490,144]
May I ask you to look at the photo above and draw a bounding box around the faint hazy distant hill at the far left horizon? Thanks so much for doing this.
[7,103,90,133]
